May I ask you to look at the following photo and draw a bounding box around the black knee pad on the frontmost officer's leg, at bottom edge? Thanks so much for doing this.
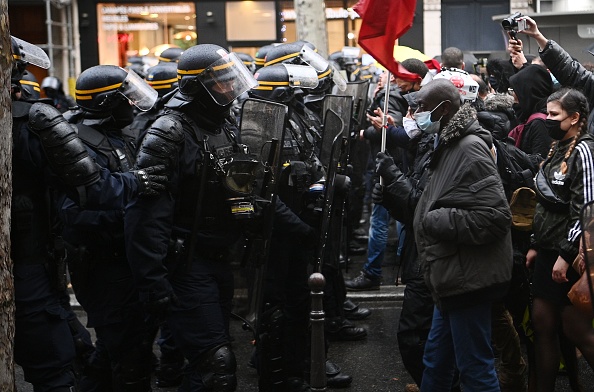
[198,344,237,392]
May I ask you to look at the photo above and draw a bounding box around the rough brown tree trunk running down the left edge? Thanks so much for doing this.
[0,0,16,392]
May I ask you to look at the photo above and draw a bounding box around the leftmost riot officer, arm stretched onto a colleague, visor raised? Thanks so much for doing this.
[10,37,162,391]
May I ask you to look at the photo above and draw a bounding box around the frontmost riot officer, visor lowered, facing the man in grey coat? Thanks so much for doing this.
[125,44,256,391]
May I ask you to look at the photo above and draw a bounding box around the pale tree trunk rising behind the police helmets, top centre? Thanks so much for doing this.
[294,0,328,58]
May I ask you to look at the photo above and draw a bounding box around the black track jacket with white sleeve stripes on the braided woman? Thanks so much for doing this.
[533,134,594,263]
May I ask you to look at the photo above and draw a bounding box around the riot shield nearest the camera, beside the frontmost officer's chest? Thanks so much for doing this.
[240,98,288,339]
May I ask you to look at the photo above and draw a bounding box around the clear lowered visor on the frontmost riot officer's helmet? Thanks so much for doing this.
[198,53,258,106]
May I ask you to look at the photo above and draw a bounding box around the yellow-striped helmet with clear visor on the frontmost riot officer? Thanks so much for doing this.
[177,44,257,106]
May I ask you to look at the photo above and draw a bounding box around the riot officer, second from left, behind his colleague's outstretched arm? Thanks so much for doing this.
[60,65,163,391]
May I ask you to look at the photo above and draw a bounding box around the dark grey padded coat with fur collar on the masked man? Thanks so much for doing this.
[414,105,512,310]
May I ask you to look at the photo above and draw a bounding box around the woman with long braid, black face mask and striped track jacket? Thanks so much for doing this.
[526,88,594,391]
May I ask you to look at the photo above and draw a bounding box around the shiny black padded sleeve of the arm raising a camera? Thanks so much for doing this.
[539,40,594,133]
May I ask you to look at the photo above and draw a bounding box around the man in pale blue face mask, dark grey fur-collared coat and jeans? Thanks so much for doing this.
[374,80,512,391]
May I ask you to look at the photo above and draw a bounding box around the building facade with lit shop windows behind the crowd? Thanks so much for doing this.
[8,0,594,94]
